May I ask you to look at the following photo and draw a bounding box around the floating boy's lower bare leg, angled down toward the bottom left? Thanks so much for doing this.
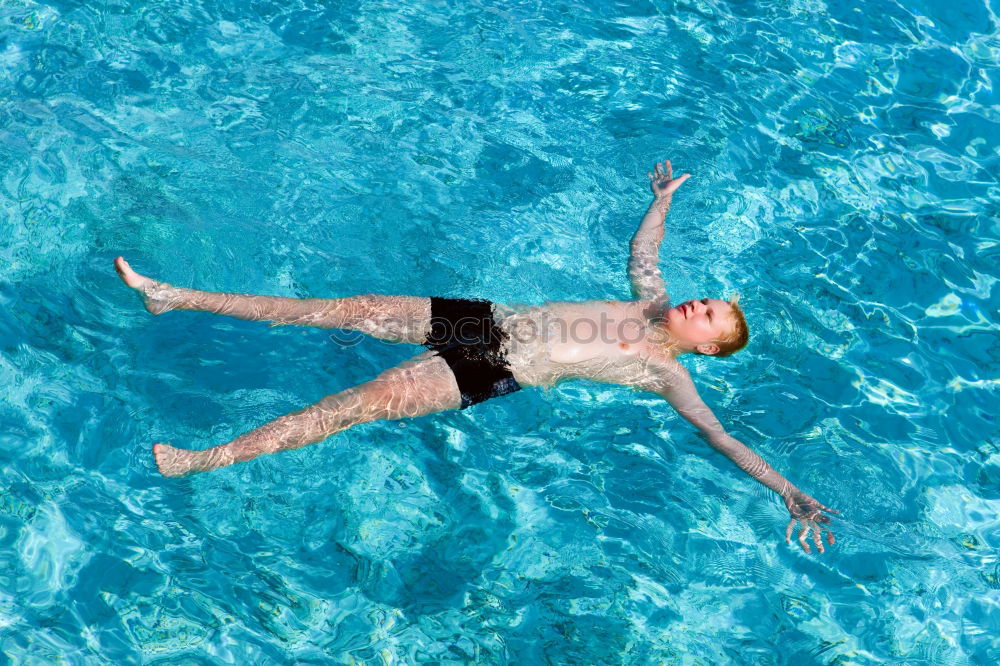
[153,352,462,476]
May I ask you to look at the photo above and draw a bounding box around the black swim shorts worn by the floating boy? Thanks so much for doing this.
[424,298,521,409]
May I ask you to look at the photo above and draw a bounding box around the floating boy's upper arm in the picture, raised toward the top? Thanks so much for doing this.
[628,161,689,302]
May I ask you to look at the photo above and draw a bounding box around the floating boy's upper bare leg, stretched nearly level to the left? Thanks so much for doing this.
[115,257,431,344]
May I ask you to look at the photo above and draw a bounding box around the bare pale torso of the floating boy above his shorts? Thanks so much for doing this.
[496,301,677,386]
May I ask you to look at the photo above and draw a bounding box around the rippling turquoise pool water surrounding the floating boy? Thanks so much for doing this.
[0,0,1000,665]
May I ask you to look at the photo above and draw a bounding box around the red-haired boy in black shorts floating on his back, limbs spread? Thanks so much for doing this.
[115,162,838,552]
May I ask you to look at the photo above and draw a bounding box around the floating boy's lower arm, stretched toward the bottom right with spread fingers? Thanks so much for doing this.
[656,365,837,553]
